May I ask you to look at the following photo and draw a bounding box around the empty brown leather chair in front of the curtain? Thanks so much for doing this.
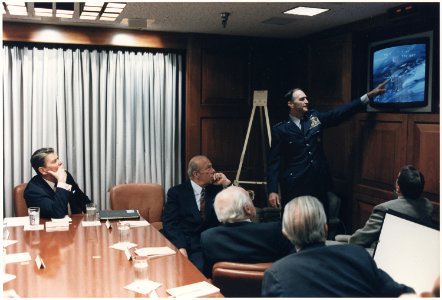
[110,183,164,230]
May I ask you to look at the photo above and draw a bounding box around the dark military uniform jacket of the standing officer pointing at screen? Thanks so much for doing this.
[267,99,362,206]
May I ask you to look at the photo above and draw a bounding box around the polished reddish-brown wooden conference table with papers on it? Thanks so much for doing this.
[3,215,222,298]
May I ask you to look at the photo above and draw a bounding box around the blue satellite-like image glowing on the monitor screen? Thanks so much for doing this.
[373,43,427,105]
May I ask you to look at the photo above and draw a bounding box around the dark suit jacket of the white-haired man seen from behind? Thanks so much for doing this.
[201,222,294,277]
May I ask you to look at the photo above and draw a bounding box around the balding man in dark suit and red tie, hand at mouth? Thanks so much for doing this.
[163,155,232,271]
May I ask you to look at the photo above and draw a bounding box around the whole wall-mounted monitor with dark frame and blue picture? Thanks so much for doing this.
[367,31,433,112]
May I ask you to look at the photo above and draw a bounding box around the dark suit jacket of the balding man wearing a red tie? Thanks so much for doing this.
[163,180,222,252]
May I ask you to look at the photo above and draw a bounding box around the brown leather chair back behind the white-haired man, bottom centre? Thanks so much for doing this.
[212,262,272,297]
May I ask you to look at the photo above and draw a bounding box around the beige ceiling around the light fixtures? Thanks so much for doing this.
[3,1,410,38]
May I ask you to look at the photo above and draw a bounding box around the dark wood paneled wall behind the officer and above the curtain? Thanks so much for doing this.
[3,8,440,231]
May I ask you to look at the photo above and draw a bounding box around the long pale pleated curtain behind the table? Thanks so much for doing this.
[1,45,183,216]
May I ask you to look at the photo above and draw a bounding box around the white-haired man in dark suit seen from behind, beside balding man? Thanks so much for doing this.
[201,186,293,277]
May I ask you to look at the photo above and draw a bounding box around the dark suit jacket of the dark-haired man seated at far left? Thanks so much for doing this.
[24,172,92,219]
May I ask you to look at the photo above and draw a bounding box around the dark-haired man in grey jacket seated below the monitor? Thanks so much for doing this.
[346,165,433,247]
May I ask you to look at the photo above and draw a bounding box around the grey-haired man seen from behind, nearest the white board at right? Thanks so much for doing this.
[262,196,414,297]
